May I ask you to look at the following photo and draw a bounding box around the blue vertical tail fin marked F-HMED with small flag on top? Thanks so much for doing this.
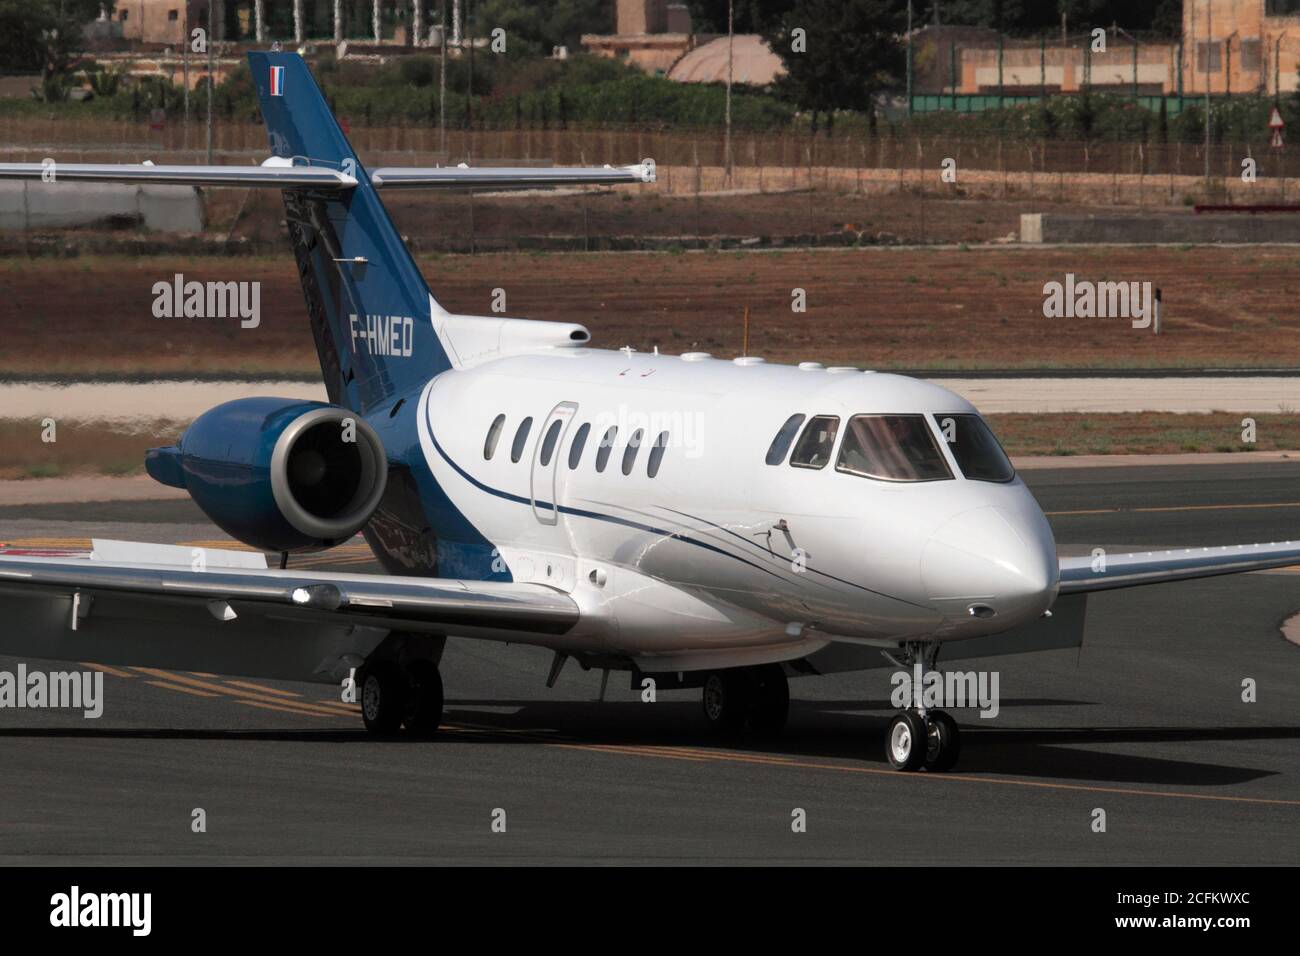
[248,52,451,414]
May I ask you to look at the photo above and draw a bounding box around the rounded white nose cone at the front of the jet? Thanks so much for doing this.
[920,506,1060,632]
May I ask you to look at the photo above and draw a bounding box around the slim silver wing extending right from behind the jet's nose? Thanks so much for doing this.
[1061,541,1300,594]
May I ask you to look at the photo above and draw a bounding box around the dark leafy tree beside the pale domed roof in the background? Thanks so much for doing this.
[764,0,906,130]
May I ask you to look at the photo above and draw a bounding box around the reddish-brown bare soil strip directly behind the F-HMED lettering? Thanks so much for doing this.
[0,247,1300,377]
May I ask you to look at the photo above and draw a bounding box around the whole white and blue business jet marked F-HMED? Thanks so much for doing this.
[0,51,1300,771]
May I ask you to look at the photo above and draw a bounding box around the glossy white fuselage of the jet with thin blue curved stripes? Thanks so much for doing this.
[419,347,1058,670]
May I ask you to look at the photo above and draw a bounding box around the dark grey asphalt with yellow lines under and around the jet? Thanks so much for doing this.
[0,462,1300,864]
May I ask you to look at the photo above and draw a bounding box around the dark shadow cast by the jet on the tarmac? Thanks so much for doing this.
[0,698,1300,787]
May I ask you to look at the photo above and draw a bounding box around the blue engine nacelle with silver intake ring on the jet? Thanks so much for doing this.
[144,398,389,551]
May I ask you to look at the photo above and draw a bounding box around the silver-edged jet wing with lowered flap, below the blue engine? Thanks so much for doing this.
[0,549,580,683]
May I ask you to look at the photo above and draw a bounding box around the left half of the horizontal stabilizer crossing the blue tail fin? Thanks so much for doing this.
[0,163,356,190]
